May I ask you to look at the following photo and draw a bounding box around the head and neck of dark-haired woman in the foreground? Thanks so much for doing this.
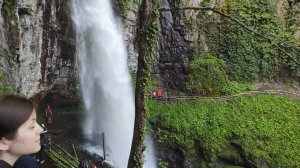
[0,95,43,168]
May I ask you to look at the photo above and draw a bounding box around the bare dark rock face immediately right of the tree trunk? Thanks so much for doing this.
[154,0,202,89]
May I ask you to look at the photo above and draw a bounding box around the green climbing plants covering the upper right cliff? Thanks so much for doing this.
[199,0,300,82]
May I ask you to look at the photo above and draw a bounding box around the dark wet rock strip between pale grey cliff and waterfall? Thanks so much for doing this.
[38,0,80,104]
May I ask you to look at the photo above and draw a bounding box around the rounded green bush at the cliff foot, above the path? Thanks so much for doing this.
[185,54,227,96]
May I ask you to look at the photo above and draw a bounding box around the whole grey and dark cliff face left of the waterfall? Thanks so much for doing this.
[0,0,77,103]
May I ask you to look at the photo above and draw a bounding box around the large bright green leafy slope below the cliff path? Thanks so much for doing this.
[149,95,300,167]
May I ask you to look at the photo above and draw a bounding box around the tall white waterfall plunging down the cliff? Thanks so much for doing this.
[72,0,135,168]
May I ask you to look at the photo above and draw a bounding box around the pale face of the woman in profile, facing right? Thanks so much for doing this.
[9,110,43,156]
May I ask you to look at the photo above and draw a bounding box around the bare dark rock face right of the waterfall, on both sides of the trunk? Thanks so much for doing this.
[120,0,206,90]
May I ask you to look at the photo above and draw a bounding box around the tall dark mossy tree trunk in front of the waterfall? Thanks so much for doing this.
[128,0,153,168]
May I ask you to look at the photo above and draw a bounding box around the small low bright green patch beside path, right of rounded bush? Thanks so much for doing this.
[222,81,256,95]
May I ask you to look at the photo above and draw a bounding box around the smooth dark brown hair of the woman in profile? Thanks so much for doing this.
[0,95,34,140]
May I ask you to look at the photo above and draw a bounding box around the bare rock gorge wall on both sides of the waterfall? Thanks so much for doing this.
[0,0,300,105]
